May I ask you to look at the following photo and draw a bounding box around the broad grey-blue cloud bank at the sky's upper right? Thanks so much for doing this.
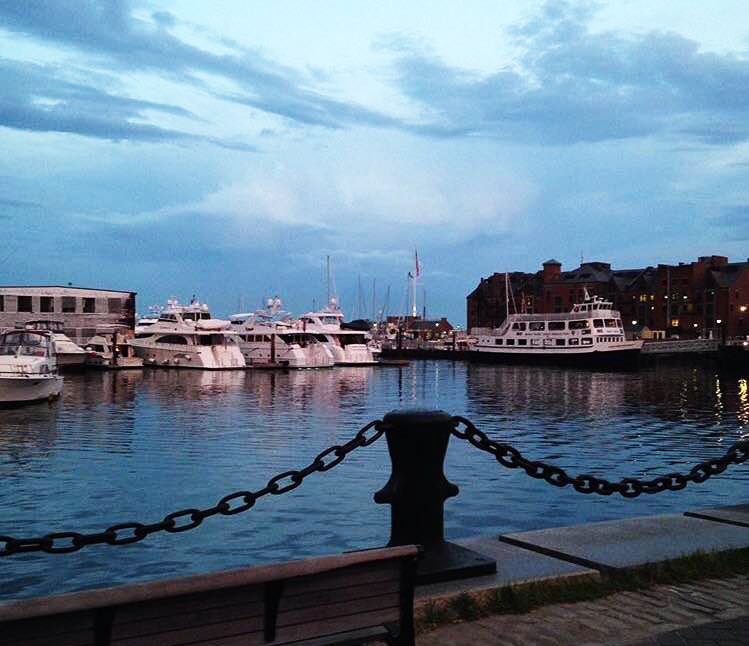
[382,0,749,145]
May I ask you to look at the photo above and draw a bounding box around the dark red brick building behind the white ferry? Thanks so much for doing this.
[466,256,749,337]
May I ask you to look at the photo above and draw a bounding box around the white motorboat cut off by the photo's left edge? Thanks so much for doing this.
[0,330,63,404]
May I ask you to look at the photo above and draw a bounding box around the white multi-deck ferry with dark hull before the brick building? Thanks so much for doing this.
[473,290,643,364]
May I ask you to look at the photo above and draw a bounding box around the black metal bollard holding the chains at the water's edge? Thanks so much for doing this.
[374,409,497,583]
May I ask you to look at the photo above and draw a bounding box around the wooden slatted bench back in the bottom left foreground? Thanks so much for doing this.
[0,546,419,646]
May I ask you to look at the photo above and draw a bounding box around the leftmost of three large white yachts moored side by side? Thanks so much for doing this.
[129,299,246,370]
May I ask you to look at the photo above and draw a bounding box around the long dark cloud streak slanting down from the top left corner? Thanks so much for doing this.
[0,0,397,138]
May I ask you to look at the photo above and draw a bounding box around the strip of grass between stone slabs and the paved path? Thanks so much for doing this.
[414,548,749,633]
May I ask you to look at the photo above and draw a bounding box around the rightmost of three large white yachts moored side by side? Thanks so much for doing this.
[297,298,377,366]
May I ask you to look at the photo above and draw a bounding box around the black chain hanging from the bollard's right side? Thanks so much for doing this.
[452,417,749,498]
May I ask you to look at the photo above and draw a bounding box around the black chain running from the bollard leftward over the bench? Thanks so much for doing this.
[0,420,386,556]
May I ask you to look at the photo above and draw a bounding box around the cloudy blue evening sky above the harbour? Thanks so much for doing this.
[0,0,749,324]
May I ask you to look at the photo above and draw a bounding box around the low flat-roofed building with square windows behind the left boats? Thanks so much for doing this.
[0,285,135,344]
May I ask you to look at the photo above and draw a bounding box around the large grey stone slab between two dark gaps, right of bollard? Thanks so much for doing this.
[500,514,749,570]
